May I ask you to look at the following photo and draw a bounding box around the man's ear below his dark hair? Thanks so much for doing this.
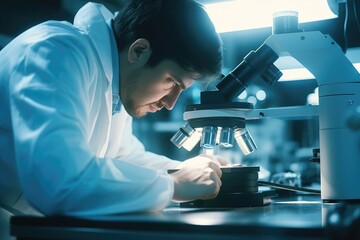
[128,38,151,63]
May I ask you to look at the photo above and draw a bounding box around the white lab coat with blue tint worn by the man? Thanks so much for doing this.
[0,3,179,215]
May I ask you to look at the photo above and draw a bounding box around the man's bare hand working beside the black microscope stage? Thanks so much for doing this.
[171,155,222,201]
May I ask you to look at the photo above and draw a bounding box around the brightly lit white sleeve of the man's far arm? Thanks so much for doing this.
[110,112,181,171]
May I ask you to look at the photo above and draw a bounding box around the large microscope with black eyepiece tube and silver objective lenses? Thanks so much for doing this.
[171,12,360,206]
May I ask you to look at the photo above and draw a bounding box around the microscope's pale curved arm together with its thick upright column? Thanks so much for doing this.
[264,32,360,202]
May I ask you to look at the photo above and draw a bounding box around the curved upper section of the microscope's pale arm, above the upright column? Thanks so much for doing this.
[264,32,360,86]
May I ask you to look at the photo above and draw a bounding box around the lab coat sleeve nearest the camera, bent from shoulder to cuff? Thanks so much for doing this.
[10,28,173,215]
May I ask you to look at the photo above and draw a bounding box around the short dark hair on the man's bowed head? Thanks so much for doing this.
[113,0,223,77]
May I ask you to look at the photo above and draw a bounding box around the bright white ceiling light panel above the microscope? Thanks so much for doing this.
[204,0,337,33]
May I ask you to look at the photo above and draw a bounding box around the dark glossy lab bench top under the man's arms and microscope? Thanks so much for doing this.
[11,195,360,240]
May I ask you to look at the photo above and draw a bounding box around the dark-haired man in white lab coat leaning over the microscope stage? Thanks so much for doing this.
[0,0,225,218]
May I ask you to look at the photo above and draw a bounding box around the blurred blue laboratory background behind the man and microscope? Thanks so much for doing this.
[0,0,360,239]
